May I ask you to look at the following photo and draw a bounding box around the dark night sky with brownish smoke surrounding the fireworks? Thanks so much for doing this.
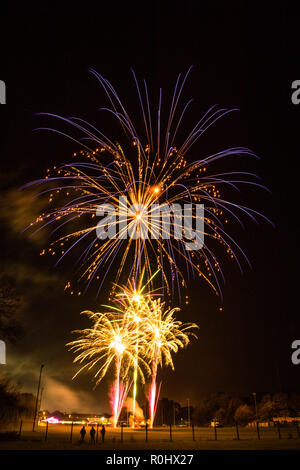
[0,1,300,412]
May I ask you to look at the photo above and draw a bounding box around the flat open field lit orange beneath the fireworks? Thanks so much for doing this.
[0,422,300,450]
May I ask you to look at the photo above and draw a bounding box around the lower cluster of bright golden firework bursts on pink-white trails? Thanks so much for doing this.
[68,278,197,427]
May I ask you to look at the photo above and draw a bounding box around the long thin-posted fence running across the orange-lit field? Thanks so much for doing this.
[0,420,300,444]
